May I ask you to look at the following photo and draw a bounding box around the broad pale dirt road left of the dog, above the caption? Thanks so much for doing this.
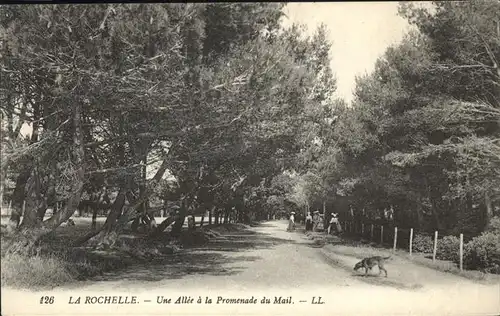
[73,222,360,291]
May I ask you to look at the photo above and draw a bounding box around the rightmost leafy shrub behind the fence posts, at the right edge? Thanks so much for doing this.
[464,232,500,273]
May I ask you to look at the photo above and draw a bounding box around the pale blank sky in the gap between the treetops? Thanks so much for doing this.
[283,2,409,102]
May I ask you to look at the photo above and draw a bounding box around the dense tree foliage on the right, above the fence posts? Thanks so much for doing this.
[292,1,500,239]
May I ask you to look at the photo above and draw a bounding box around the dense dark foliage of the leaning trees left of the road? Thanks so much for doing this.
[0,3,334,248]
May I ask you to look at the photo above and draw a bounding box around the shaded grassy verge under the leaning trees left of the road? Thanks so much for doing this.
[1,217,238,289]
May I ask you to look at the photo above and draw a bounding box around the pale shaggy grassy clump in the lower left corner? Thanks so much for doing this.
[1,253,74,289]
